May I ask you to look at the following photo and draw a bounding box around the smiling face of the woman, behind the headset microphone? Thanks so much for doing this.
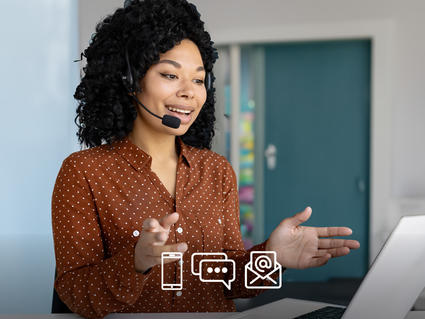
[137,39,207,135]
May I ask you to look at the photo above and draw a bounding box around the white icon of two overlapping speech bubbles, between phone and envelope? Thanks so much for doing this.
[191,253,236,290]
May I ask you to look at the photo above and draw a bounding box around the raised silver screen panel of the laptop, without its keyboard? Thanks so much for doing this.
[342,215,425,319]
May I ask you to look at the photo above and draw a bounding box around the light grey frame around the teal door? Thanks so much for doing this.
[212,20,394,264]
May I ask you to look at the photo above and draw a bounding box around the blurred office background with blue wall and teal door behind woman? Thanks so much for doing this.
[0,0,425,314]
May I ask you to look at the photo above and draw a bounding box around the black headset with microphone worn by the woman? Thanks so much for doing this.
[122,43,212,129]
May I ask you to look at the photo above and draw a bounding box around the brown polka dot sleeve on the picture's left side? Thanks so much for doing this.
[52,155,149,318]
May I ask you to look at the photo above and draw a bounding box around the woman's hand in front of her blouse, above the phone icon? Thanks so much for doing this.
[134,213,187,273]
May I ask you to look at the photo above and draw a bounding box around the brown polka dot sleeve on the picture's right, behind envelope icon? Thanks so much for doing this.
[219,161,278,299]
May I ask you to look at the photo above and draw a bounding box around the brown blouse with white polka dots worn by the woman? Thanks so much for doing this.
[52,138,274,318]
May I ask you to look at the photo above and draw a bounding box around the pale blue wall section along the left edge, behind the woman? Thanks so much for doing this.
[0,0,78,314]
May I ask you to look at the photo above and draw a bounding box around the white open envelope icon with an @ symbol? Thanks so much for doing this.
[245,251,282,289]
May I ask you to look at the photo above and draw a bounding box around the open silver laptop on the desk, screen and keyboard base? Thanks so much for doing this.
[228,215,425,319]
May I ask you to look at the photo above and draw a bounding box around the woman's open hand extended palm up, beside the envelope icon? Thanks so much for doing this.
[266,207,360,269]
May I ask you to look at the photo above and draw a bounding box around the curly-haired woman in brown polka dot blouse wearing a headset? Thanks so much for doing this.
[52,0,359,318]
